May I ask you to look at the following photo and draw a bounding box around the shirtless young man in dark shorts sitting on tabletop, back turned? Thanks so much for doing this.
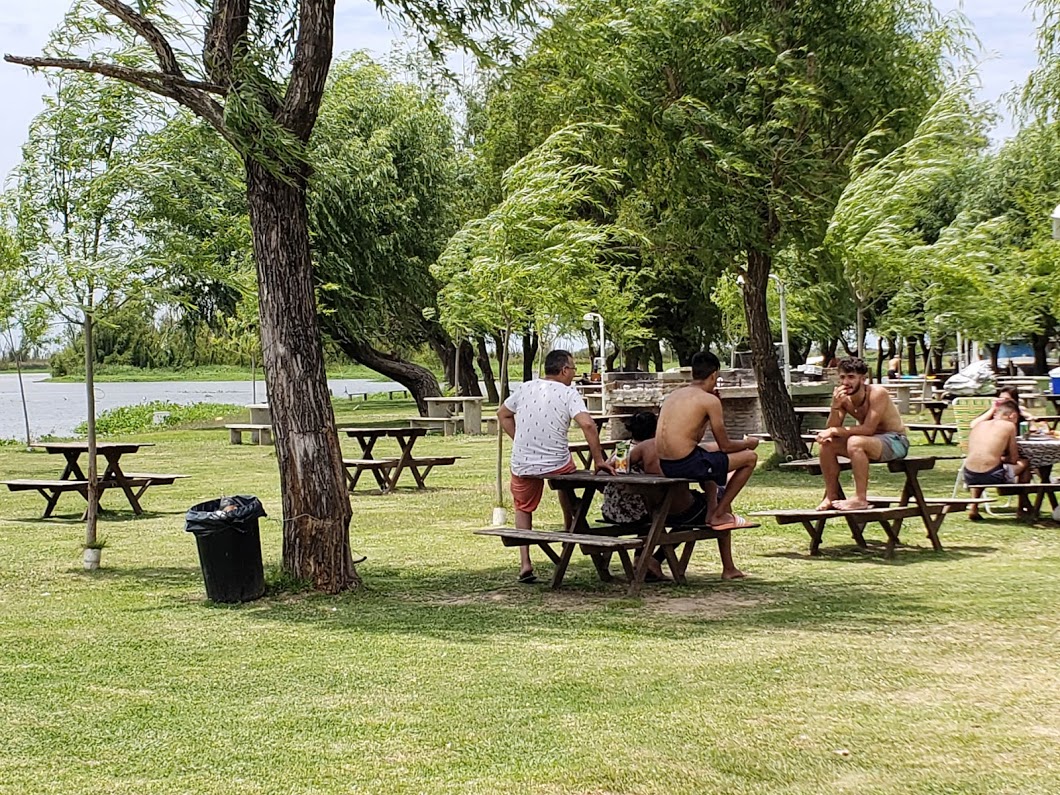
[655,351,758,536]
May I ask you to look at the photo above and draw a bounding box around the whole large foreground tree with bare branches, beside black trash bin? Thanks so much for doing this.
[4,0,525,593]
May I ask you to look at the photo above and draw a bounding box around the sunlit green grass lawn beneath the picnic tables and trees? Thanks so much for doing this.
[0,401,1060,795]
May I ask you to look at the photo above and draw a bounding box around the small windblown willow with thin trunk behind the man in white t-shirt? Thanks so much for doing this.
[431,124,644,507]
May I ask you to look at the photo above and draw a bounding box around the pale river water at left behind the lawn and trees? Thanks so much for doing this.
[0,373,404,440]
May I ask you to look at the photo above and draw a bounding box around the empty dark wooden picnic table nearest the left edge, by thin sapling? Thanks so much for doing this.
[2,441,188,518]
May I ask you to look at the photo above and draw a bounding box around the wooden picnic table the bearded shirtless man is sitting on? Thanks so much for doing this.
[754,456,975,558]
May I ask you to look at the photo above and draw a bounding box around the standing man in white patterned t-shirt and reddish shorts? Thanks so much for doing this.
[497,351,615,584]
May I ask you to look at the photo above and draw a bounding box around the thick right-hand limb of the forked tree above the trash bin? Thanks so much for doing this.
[277,0,335,141]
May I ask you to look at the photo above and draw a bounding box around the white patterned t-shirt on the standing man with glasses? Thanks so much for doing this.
[505,378,588,476]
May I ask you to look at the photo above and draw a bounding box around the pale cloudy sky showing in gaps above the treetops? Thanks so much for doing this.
[0,0,1036,183]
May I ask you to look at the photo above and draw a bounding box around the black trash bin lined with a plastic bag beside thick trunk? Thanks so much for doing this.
[184,496,267,602]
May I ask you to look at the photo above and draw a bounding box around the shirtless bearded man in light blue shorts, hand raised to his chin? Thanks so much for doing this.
[817,357,909,511]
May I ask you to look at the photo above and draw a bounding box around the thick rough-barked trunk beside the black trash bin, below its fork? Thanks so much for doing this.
[246,158,360,594]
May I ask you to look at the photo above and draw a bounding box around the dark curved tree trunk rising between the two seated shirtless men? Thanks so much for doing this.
[743,251,809,458]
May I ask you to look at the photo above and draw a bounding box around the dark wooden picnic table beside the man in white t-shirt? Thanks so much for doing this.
[477,471,755,596]
